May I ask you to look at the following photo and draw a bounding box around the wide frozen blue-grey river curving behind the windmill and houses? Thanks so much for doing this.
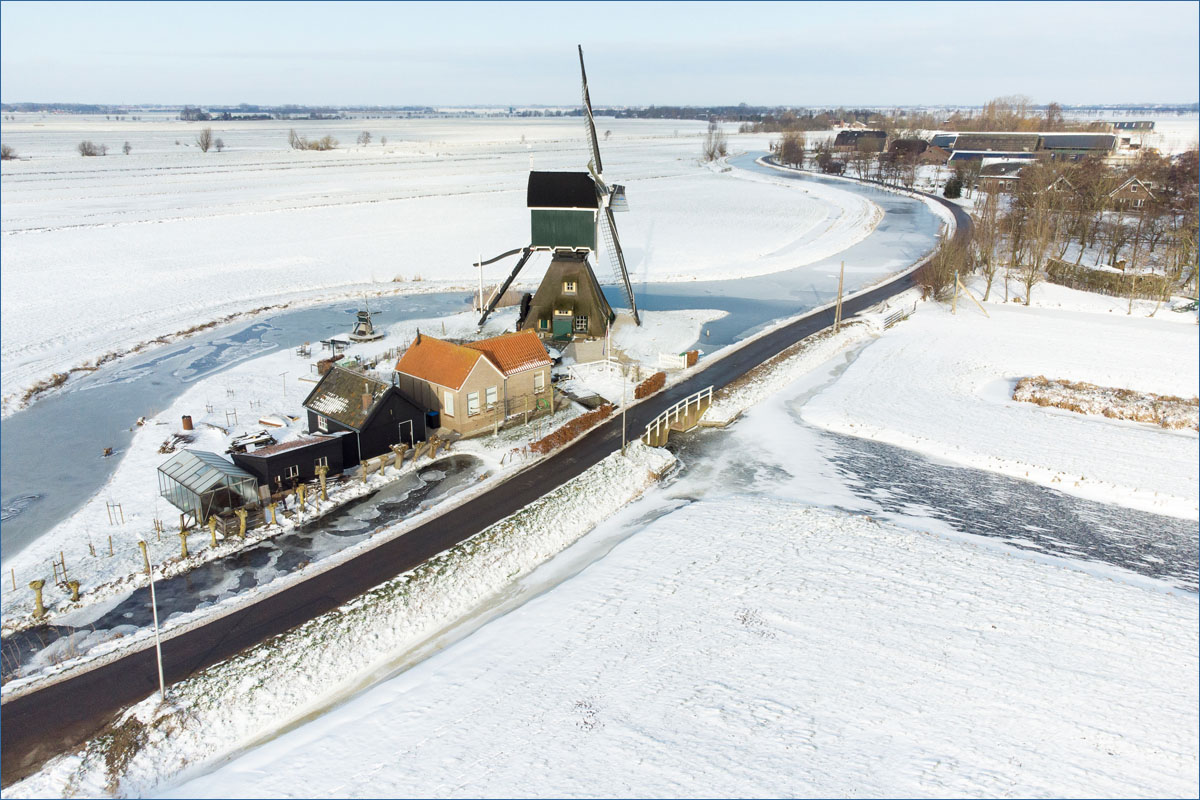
[0,154,942,557]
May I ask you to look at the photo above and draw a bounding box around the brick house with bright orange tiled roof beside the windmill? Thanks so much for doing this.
[396,331,551,437]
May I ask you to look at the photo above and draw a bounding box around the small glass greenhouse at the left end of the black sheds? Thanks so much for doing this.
[158,450,258,524]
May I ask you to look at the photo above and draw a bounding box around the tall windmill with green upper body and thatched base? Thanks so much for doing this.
[476,46,642,339]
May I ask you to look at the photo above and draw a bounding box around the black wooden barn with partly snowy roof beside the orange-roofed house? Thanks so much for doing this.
[304,367,425,468]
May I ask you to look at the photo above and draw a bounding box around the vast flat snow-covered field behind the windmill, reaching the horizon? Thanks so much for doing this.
[0,114,878,414]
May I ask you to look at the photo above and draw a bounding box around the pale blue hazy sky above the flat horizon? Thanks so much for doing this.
[0,1,1200,106]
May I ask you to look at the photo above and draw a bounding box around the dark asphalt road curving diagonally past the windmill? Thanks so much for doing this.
[0,179,971,786]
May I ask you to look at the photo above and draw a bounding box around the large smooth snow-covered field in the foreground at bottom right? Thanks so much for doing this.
[162,496,1200,796]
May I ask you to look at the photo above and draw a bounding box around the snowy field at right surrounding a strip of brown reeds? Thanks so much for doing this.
[804,278,1200,519]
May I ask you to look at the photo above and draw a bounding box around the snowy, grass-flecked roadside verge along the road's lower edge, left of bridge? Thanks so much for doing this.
[6,444,673,796]
